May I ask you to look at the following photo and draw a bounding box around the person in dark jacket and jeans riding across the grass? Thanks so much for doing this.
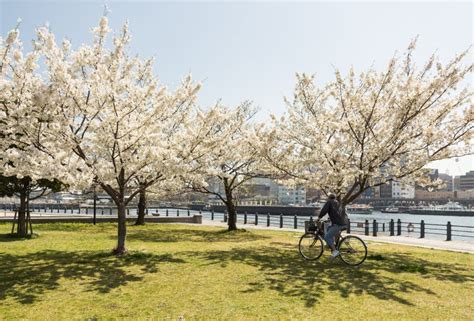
[317,194,347,258]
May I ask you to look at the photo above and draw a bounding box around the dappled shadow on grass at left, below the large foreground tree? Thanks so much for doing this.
[0,250,185,304]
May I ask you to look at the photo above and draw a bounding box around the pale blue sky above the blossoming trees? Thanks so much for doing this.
[0,0,474,175]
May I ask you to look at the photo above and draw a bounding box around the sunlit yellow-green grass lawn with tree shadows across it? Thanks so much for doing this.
[0,224,474,320]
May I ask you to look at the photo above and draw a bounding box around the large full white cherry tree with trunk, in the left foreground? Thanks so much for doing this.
[35,16,200,254]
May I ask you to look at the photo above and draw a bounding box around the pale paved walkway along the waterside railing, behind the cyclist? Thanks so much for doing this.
[202,219,474,253]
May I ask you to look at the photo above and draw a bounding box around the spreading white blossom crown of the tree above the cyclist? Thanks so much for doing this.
[262,41,474,206]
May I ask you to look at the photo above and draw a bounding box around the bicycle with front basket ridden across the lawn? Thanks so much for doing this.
[298,219,367,266]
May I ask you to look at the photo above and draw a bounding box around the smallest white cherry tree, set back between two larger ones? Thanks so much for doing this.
[185,102,263,231]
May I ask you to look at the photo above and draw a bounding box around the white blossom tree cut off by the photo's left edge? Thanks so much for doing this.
[0,21,67,237]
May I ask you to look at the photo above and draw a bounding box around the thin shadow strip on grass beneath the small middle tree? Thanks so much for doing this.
[127,227,270,243]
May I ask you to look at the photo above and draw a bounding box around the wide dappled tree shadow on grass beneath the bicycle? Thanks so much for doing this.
[188,247,474,307]
